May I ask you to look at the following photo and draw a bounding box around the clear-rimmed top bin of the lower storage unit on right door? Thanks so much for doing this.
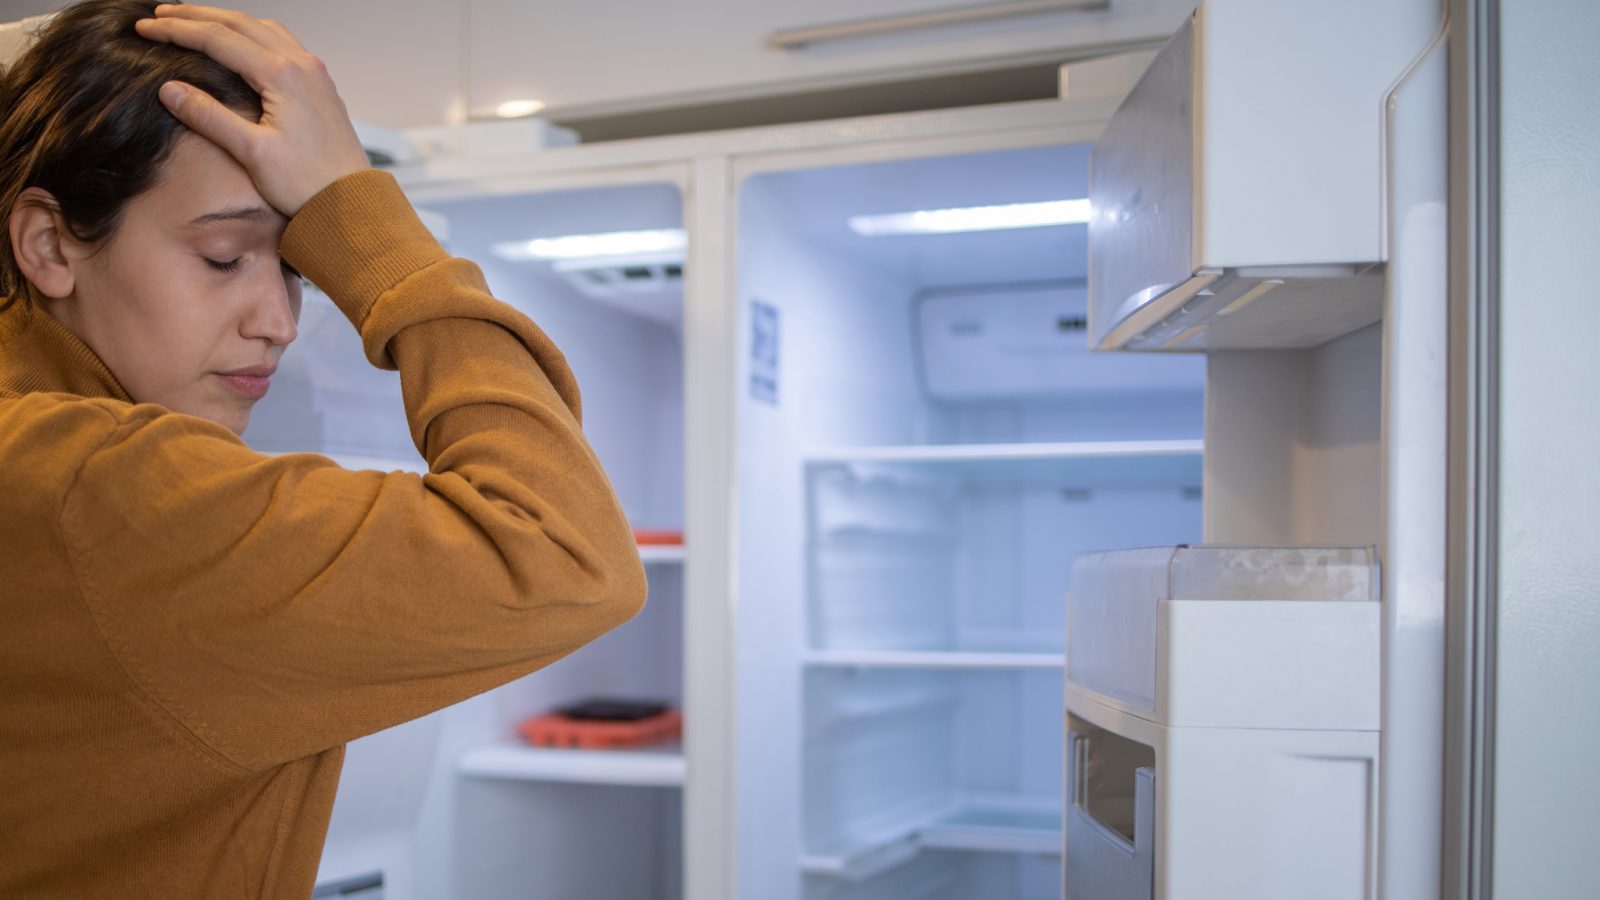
[1067,544,1379,729]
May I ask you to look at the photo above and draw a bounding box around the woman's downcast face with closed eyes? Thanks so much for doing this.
[45,133,301,434]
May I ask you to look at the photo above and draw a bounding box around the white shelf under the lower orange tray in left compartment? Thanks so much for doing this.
[456,741,685,788]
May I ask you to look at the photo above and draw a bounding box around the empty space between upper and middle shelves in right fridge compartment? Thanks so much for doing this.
[806,461,1200,655]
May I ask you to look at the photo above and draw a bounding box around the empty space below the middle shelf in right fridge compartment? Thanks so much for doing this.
[802,668,1062,881]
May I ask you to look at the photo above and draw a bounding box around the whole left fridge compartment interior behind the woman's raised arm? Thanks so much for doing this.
[245,184,683,900]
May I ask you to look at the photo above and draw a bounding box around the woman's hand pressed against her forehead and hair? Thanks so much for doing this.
[136,3,366,216]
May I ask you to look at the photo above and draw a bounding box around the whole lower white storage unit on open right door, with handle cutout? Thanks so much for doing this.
[1064,544,1379,900]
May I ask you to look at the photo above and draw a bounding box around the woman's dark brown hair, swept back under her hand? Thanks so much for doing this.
[0,0,261,311]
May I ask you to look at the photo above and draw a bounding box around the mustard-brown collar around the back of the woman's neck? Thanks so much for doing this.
[0,301,133,404]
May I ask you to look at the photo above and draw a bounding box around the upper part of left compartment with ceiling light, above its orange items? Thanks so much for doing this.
[243,183,683,528]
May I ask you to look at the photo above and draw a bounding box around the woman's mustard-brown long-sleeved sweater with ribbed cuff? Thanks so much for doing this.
[0,171,645,900]
